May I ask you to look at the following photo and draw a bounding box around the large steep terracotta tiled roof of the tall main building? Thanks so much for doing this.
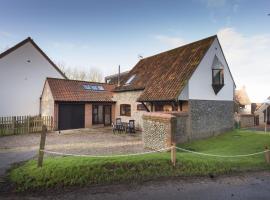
[115,36,217,101]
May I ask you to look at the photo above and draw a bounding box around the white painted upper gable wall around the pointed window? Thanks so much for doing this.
[179,39,235,101]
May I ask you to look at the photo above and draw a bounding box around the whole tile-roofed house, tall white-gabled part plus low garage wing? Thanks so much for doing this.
[41,36,235,141]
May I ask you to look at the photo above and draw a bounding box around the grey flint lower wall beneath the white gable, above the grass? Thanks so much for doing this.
[188,100,234,140]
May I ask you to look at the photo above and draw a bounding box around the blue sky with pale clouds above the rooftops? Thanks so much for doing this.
[0,0,270,102]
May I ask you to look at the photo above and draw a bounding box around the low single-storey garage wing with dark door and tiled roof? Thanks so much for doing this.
[41,78,115,130]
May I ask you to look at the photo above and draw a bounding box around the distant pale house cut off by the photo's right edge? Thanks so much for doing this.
[254,97,270,125]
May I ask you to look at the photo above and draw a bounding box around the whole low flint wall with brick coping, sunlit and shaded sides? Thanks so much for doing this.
[143,112,188,149]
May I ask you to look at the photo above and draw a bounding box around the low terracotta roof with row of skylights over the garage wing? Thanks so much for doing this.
[47,78,114,102]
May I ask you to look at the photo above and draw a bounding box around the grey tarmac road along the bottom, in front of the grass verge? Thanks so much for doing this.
[0,172,270,200]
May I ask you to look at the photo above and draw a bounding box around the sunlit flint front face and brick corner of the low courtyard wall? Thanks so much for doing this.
[142,113,176,150]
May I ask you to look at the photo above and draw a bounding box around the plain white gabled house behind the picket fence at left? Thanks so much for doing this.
[0,37,66,116]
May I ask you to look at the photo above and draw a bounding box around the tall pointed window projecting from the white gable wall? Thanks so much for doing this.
[212,56,224,94]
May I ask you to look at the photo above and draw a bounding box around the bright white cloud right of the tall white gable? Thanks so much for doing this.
[218,27,270,102]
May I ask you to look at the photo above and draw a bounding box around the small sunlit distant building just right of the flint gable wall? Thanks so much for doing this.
[235,86,251,114]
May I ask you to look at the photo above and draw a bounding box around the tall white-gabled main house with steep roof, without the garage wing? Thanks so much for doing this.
[113,36,235,136]
